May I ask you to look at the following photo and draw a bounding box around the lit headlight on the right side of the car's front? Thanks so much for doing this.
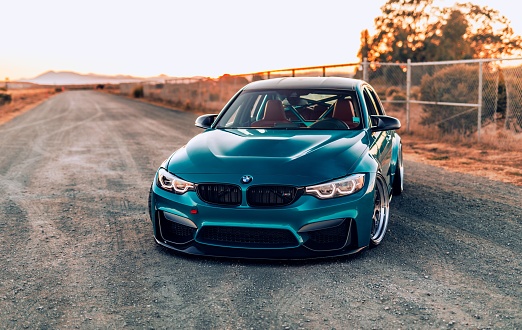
[306,174,364,199]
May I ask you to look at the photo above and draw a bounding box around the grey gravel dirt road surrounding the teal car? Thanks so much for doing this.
[0,91,522,329]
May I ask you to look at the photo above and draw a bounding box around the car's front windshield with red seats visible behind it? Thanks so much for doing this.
[216,90,362,129]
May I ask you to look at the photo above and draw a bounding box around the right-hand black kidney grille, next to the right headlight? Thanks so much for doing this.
[247,186,299,206]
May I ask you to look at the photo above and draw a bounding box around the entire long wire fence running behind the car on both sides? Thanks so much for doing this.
[125,58,522,143]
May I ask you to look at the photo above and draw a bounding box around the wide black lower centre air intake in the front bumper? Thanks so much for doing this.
[197,226,298,248]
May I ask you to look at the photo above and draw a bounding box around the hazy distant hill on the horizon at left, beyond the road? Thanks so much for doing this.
[18,71,170,86]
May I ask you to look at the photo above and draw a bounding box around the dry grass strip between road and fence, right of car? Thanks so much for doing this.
[387,105,522,186]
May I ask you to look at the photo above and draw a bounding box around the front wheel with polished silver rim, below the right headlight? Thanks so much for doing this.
[370,176,390,247]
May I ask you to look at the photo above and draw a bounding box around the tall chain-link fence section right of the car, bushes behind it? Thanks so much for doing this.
[362,58,522,147]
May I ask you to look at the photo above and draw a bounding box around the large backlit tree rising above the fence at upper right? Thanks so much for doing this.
[359,0,522,62]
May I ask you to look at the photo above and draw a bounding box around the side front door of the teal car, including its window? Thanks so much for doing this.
[363,86,393,186]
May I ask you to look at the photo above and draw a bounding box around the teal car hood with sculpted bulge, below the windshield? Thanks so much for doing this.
[167,129,367,184]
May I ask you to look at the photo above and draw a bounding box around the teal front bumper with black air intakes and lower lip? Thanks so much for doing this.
[150,171,374,259]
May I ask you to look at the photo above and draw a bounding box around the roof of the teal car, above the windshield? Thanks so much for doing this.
[243,77,364,90]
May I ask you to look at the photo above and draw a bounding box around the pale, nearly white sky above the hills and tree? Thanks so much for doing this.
[0,0,522,81]
